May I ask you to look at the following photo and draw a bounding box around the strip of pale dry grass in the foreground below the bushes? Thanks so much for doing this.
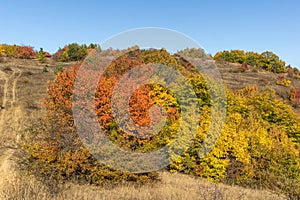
[0,172,285,200]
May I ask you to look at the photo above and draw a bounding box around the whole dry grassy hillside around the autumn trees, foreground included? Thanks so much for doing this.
[0,53,300,199]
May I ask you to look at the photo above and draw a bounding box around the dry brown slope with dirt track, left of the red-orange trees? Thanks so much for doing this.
[0,58,75,195]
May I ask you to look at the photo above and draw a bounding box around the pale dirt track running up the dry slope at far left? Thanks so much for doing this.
[0,68,22,189]
